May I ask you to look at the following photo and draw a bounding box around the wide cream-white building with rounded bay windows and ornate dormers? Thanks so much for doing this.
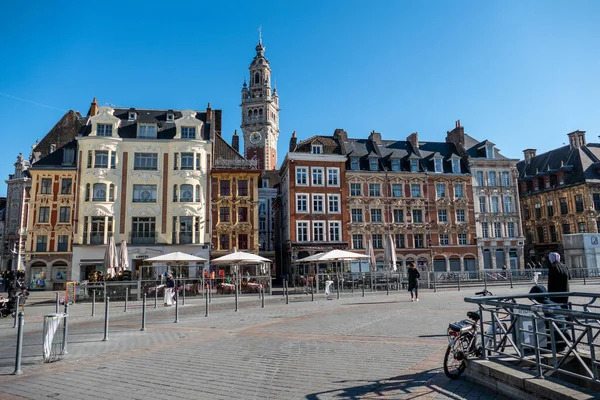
[71,104,216,280]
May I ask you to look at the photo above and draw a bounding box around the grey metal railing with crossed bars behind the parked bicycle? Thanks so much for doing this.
[465,292,600,384]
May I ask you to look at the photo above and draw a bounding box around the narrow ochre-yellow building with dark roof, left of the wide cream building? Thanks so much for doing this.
[25,140,77,290]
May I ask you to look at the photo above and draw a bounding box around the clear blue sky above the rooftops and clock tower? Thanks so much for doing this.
[0,0,600,196]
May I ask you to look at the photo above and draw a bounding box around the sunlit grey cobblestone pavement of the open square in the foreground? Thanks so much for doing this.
[0,285,600,400]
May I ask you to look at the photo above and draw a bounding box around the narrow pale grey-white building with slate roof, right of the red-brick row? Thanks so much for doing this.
[446,121,524,269]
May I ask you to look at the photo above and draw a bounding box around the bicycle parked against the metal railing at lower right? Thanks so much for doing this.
[444,290,507,379]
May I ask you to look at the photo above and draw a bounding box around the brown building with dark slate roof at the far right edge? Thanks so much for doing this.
[517,130,600,264]
